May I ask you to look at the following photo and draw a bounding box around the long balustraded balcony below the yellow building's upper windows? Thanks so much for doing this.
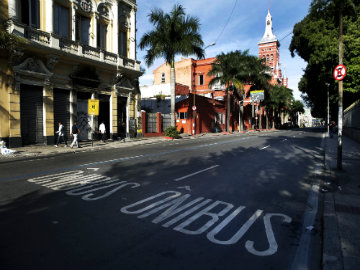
[9,20,140,71]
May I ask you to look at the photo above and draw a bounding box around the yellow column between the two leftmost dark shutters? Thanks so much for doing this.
[43,78,55,145]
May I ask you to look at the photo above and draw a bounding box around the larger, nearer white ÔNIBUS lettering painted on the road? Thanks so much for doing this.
[120,191,292,256]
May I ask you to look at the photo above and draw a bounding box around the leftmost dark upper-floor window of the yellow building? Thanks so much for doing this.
[20,0,40,28]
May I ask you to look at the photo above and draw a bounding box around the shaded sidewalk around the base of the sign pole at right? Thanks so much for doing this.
[322,136,360,269]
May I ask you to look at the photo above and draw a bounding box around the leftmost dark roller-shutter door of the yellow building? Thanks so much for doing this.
[20,84,44,145]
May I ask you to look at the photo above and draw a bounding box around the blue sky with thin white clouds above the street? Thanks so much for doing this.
[136,0,311,99]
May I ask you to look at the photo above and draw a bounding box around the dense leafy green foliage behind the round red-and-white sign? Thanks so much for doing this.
[289,0,360,117]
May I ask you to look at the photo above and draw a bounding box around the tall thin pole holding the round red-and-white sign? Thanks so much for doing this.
[337,0,343,170]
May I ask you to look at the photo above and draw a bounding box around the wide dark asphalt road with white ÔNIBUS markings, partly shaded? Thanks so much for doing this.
[0,129,322,269]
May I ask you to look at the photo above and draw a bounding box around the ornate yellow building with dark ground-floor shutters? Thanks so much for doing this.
[0,0,141,147]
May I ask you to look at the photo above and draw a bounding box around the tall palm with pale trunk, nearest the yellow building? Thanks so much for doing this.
[139,5,204,126]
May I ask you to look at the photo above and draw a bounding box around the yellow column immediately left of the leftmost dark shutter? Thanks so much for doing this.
[9,82,22,148]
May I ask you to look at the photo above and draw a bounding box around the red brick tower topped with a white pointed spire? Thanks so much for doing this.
[259,10,287,85]
